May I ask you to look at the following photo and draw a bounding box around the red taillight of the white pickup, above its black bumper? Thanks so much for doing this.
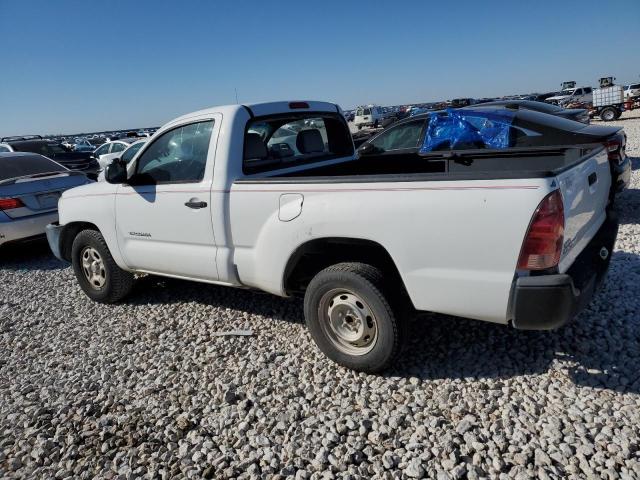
[518,190,564,270]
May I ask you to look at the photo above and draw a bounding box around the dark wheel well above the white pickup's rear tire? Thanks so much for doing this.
[284,237,404,295]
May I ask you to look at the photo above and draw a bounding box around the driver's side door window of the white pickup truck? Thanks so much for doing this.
[135,120,213,185]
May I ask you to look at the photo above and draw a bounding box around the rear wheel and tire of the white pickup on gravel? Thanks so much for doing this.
[304,263,404,373]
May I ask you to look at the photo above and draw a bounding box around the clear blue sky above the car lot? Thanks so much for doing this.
[0,0,640,135]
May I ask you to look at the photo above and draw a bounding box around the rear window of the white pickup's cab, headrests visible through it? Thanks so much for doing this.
[242,112,354,174]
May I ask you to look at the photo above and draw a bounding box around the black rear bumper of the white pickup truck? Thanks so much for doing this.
[512,212,618,330]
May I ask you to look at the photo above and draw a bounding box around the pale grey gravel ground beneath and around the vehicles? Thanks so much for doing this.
[0,115,640,479]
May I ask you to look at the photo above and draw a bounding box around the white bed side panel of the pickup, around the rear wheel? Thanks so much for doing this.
[230,179,551,323]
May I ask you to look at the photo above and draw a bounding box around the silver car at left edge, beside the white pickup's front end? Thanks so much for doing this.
[0,152,90,246]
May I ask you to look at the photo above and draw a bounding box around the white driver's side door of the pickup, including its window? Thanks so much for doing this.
[115,115,221,280]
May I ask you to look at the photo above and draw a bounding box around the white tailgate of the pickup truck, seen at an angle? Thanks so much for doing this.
[557,147,611,273]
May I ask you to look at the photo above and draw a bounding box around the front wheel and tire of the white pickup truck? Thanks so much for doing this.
[71,230,133,303]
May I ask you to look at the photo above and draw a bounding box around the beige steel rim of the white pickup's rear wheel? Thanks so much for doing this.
[319,289,378,355]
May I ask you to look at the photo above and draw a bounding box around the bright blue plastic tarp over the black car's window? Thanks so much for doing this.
[420,109,513,153]
